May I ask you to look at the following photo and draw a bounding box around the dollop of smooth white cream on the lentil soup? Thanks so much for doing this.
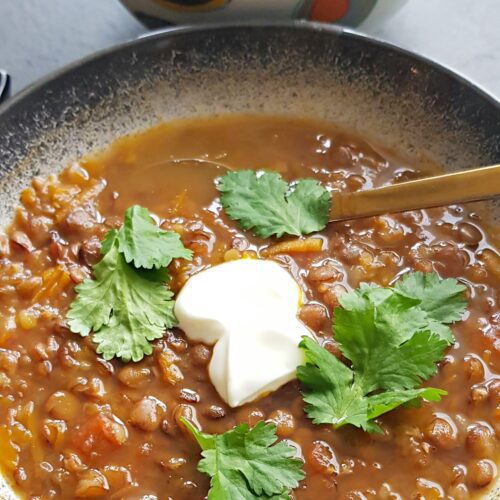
[175,259,311,407]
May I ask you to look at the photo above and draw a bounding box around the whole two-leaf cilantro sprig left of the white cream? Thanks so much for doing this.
[67,206,191,362]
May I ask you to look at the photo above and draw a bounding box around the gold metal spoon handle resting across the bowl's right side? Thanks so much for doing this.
[330,165,500,221]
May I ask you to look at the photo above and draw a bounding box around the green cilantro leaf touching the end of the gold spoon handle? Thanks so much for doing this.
[217,170,331,238]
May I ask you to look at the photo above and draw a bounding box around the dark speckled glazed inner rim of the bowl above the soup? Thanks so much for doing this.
[0,22,500,498]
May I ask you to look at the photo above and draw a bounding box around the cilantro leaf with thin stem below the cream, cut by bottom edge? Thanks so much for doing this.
[182,418,304,500]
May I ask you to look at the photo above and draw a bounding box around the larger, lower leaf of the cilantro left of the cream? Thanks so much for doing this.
[67,237,176,361]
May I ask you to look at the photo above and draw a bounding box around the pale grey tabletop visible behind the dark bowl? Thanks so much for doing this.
[0,0,500,98]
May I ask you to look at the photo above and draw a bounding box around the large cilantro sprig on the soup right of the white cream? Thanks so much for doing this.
[297,273,465,432]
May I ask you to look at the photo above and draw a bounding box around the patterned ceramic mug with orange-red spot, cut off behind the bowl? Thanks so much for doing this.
[122,0,406,28]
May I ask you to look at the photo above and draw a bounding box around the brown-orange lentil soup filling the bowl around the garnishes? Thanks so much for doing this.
[0,116,500,499]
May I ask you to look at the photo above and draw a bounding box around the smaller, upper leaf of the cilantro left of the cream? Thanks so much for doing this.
[117,205,192,269]
